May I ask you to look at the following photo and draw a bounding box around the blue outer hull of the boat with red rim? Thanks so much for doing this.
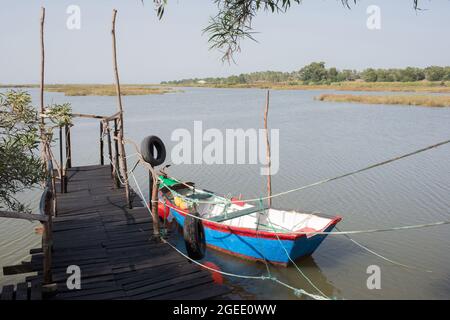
[164,207,340,266]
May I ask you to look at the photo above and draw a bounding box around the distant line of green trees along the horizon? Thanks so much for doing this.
[161,62,450,85]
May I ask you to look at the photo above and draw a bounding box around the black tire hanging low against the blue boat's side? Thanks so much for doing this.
[183,213,206,260]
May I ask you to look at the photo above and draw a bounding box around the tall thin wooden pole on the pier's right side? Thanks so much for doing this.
[111,9,132,208]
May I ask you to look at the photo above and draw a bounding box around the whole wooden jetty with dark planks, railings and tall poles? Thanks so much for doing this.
[0,8,236,300]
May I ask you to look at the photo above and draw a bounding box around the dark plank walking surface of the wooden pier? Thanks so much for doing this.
[0,166,230,300]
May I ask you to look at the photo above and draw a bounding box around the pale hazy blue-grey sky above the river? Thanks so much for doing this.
[0,0,450,84]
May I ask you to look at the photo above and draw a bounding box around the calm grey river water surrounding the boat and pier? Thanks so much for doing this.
[0,88,450,299]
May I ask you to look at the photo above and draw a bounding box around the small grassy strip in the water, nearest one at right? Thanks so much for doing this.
[315,94,450,108]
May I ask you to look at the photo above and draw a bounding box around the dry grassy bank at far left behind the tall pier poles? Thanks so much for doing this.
[0,84,181,96]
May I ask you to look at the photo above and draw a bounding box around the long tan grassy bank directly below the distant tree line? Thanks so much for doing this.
[163,81,450,93]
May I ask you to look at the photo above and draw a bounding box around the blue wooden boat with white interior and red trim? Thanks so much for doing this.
[158,176,342,266]
